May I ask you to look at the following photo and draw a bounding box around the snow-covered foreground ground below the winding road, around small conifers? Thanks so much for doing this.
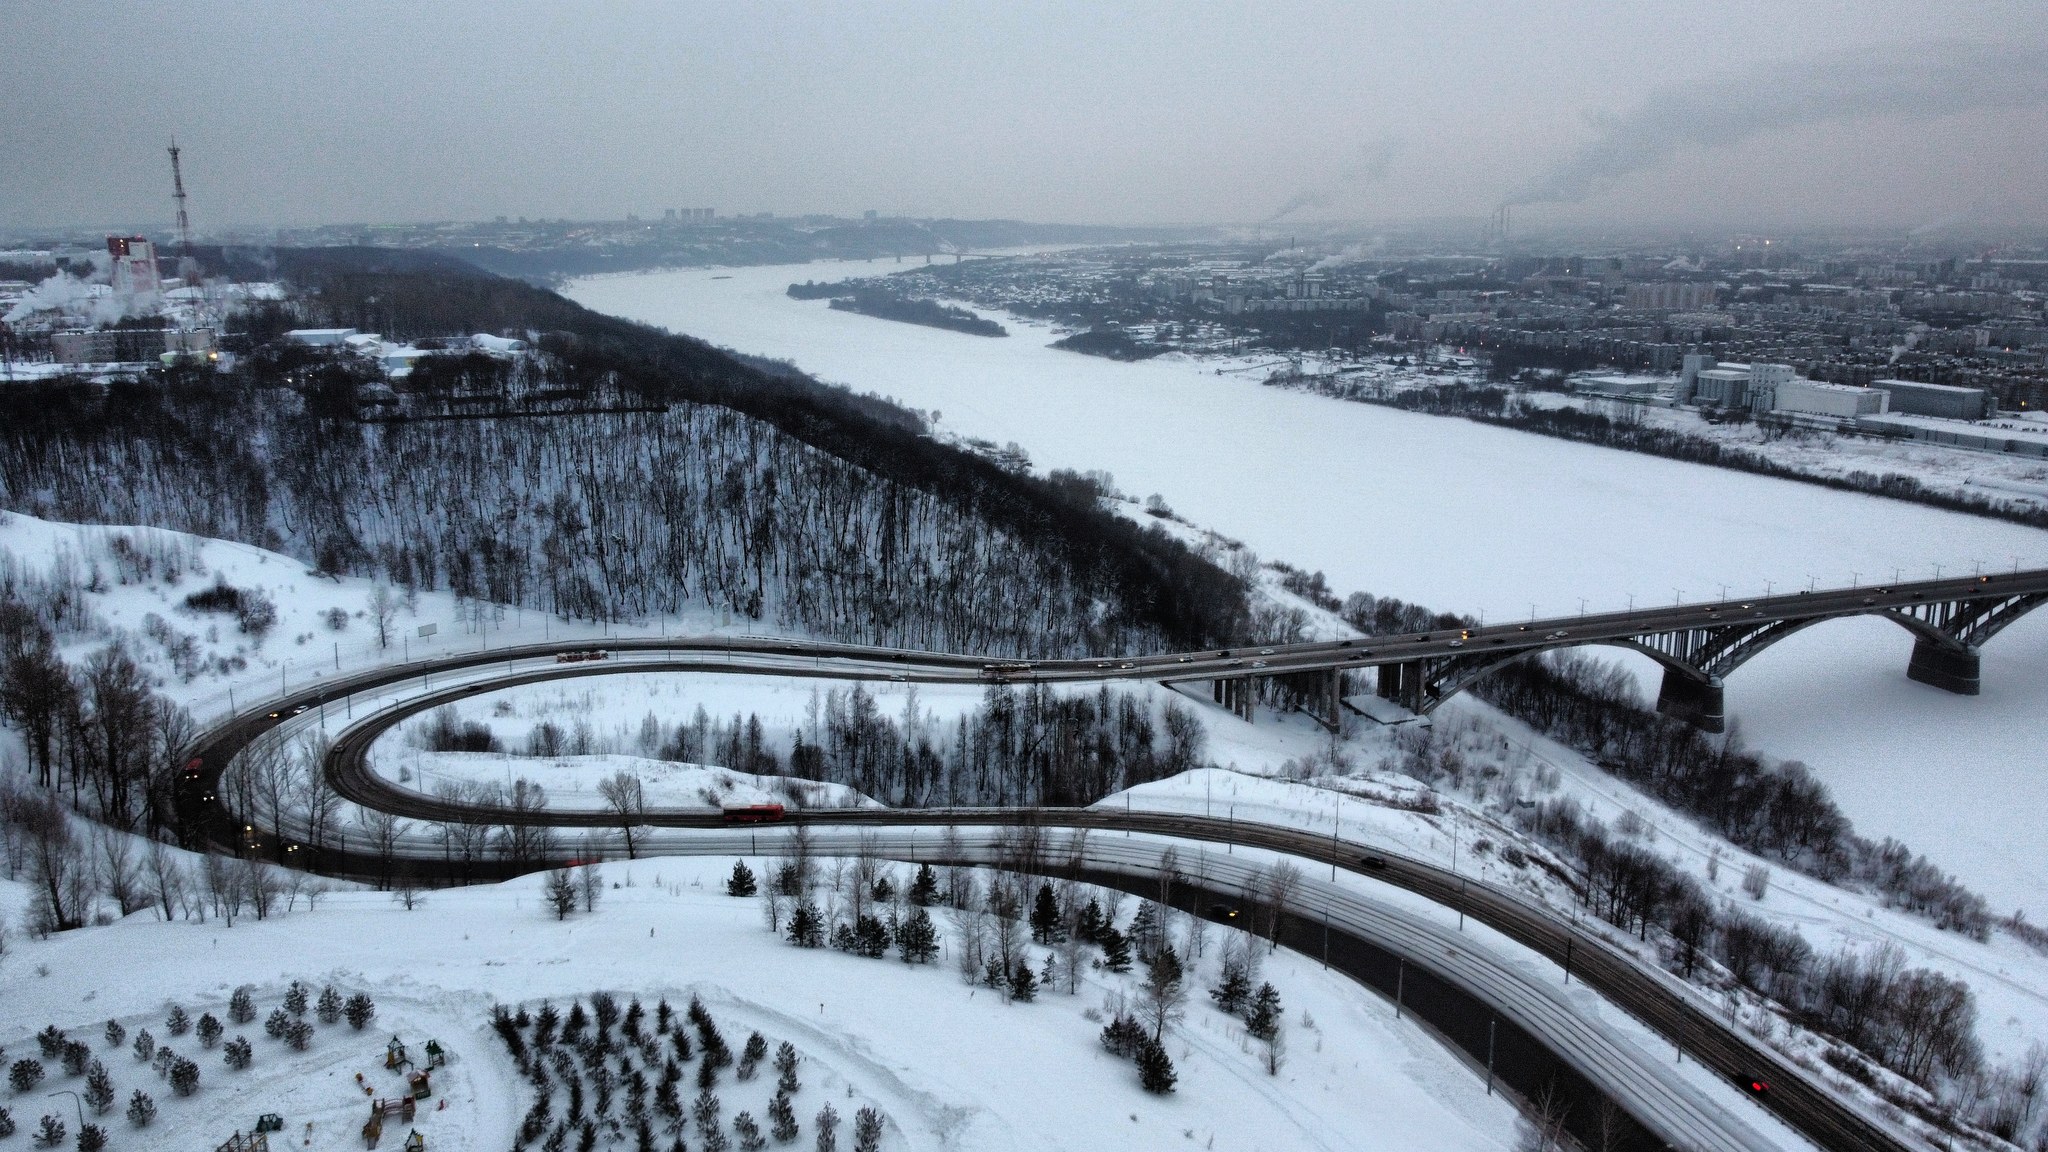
[0,859,1513,1152]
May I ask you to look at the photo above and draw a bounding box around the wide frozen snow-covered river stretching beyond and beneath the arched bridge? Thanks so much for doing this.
[567,262,2048,920]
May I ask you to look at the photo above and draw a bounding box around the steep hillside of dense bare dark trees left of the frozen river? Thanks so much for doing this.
[0,248,1245,654]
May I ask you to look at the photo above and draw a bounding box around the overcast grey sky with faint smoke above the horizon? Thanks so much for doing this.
[0,0,2048,230]
